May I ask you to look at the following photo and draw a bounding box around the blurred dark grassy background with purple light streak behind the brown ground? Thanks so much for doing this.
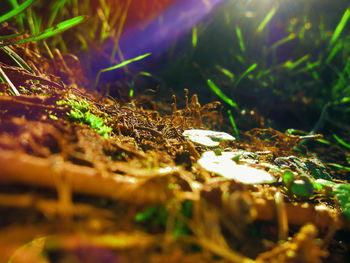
[1,0,350,138]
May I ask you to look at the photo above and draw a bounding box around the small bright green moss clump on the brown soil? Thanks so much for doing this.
[57,94,112,139]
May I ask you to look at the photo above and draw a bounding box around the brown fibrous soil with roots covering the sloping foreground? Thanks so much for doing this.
[0,41,350,262]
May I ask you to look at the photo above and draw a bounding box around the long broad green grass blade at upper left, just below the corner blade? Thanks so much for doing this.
[0,16,86,47]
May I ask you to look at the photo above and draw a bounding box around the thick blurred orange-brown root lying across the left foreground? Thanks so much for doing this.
[0,150,173,204]
